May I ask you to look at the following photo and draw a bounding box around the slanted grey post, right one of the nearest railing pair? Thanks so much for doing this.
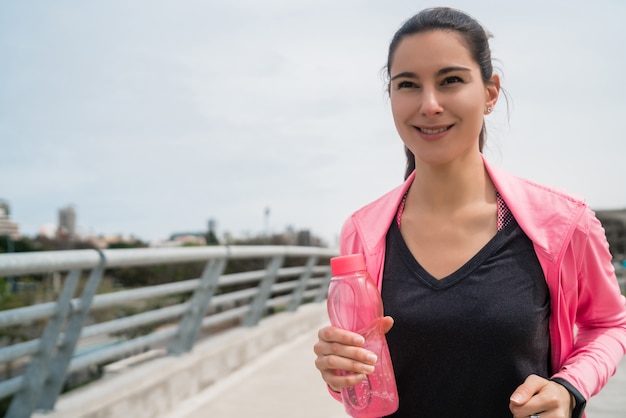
[37,250,106,411]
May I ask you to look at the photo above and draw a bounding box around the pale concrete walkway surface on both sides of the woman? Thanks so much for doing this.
[168,304,626,418]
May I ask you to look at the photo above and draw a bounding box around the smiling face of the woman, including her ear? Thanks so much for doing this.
[388,31,500,171]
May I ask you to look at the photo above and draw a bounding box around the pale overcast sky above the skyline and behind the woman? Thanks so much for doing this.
[0,0,626,244]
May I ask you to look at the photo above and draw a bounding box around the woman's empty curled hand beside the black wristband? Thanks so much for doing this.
[509,374,574,418]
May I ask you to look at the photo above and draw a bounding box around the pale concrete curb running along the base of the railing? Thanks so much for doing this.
[33,304,327,418]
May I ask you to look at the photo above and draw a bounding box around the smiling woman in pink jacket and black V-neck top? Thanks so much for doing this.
[315,8,626,418]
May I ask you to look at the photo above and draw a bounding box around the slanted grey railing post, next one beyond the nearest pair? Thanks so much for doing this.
[167,257,227,355]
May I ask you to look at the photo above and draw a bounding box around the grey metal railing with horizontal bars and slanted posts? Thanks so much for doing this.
[0,246,337,418]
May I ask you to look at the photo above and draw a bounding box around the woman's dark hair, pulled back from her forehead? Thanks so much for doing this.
[387,7,493,179]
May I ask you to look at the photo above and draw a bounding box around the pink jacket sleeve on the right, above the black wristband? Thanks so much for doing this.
[553,208,626,399]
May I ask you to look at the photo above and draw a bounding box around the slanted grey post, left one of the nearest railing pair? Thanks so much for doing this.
[7,270,80,418]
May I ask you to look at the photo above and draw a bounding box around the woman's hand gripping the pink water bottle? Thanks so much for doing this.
[313,316,393,392]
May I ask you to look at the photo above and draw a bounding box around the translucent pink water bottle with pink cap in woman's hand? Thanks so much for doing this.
[327,254,398,418]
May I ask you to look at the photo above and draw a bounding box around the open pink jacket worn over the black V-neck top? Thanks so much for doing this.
[341,156,626,399]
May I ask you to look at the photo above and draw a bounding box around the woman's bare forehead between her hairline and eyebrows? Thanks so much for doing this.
[390,30,478,73]
